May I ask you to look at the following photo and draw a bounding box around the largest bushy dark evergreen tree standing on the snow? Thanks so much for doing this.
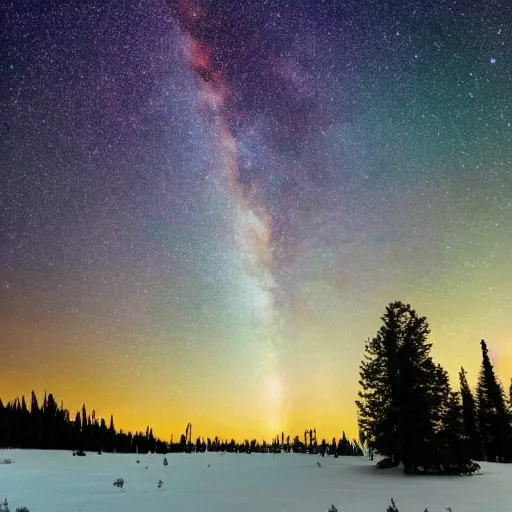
[357,302,464,473]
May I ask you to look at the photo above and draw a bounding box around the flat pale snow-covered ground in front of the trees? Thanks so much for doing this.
[0,450,512,512]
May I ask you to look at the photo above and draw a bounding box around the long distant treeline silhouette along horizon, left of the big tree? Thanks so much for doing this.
[0,391,363,457]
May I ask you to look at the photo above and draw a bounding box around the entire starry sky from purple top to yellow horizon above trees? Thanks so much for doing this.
[0,0,512,439]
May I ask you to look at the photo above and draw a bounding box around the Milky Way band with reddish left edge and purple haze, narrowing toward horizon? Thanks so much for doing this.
[171,1,362,431]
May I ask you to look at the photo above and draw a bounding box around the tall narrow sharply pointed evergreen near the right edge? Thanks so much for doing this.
[477,340,512,462]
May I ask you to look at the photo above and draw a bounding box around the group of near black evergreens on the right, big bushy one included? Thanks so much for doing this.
[356,302,512,474]
